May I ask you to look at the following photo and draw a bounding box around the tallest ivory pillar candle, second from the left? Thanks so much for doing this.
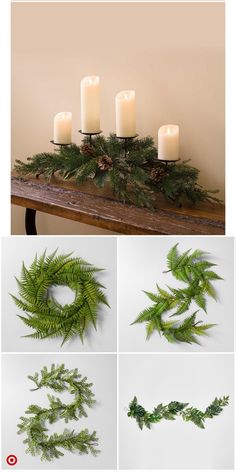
[80,76,100,133]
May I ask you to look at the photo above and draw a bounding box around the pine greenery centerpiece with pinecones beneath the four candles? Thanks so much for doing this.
[15,134,220,209]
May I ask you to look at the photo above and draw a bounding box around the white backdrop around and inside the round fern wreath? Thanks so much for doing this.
[2,236,116,352]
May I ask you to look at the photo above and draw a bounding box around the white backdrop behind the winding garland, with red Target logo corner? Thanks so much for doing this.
[2,354,116,470]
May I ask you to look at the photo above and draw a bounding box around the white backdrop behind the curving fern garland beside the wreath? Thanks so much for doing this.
[119,237,234,352]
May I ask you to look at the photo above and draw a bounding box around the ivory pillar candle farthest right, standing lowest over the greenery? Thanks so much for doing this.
[158,125,179,161]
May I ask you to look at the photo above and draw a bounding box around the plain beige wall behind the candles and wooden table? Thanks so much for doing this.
[12,3,224,234]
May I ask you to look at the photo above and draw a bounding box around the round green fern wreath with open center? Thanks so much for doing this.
[11,250,109,345]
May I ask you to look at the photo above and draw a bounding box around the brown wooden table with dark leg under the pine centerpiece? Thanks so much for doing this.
[11,176,225,235]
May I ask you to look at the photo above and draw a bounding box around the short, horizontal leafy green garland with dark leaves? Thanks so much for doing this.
[127,396,229,429]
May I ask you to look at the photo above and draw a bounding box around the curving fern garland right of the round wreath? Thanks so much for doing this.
[132,243,222,344]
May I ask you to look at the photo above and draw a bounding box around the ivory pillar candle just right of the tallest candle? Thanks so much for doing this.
[116,90,136,138]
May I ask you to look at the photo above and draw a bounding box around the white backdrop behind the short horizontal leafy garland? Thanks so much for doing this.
[119,354,234,469]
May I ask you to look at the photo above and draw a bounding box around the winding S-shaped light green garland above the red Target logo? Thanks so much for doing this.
[17,364,100,461]
